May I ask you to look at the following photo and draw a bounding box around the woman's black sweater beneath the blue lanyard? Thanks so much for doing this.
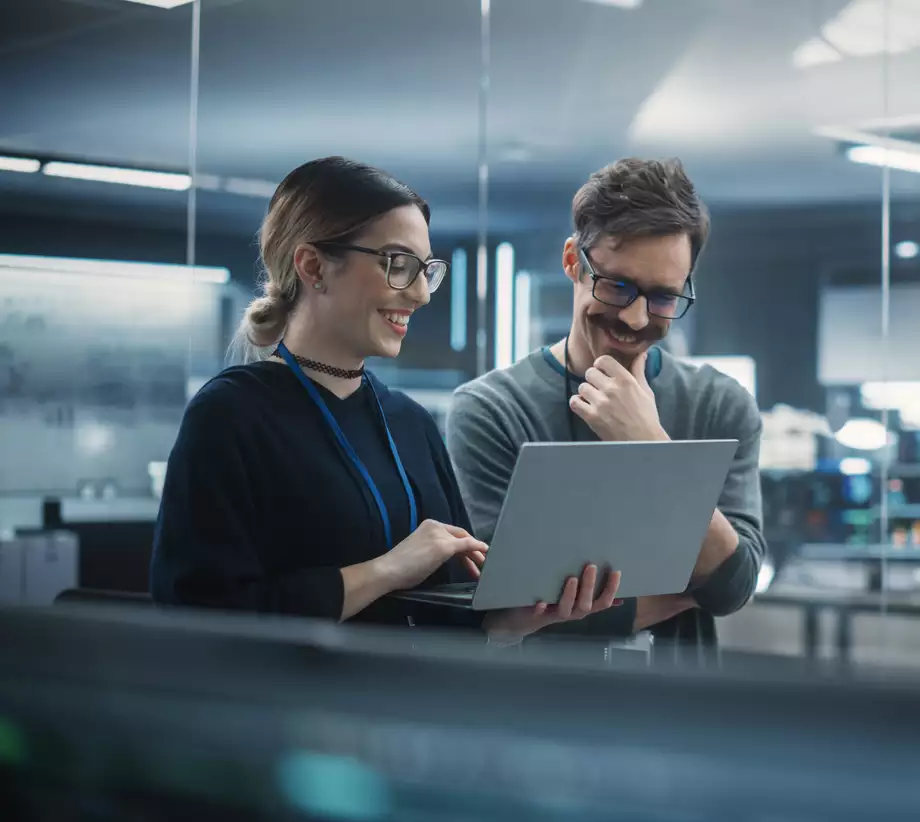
[151,362,478,625]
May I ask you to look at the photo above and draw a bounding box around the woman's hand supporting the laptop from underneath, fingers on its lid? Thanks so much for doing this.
[482,565,622,643]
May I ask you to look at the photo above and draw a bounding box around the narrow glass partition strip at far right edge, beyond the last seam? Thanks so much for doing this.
[864,1,920,669]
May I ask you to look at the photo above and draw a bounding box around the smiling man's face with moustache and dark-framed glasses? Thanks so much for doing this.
[563,234,692,368]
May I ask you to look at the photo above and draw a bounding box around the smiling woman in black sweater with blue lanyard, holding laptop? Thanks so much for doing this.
[151,158,619,641]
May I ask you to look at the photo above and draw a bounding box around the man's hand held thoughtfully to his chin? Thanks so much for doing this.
[569,352,669,442]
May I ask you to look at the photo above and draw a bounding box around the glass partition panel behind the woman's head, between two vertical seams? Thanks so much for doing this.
[191,0,480,432]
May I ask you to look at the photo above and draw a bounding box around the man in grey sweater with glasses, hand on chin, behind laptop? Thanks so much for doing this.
[447,159,765,636]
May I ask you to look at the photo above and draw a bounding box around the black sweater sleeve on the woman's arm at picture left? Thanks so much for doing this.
[150,393,344,619]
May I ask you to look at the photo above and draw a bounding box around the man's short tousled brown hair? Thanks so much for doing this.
[572,157,709,270]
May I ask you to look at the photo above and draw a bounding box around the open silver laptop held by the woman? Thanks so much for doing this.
[396,440,738,611]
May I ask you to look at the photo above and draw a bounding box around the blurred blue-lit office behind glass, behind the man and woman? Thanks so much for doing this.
[0,0,920,669]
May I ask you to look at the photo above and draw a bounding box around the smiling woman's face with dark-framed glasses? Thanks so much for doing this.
[307,205,431,360]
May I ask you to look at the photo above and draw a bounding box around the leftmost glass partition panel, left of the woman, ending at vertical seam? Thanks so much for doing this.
[0,0,196,604]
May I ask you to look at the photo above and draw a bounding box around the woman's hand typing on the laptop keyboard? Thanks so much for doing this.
[375,520,489,591]
